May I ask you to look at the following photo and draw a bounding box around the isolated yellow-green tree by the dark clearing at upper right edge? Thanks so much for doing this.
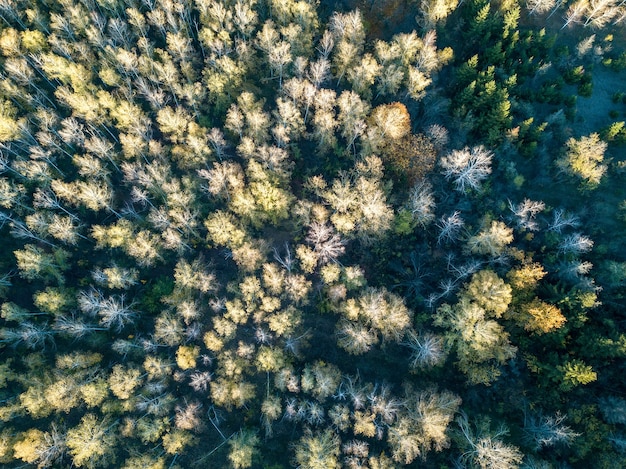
[556,133,607,189]
